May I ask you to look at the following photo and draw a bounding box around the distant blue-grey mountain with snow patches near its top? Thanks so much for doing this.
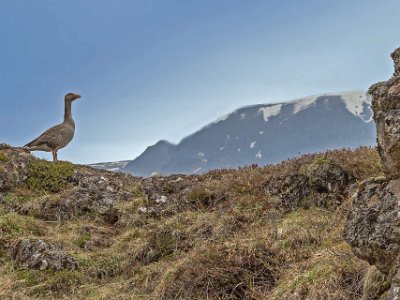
[90,91,375,176]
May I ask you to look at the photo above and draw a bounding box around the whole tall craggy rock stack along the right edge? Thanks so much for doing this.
[344,48,400,299]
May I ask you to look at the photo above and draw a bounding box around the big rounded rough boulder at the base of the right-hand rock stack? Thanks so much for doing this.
[344,179,400,275]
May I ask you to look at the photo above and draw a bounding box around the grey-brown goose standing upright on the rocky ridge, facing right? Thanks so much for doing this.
[24,93,81,161]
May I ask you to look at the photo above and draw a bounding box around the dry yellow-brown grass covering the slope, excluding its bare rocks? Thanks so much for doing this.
[0,148,386,300]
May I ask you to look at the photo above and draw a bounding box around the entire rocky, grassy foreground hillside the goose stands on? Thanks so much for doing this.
[0,145,386,300]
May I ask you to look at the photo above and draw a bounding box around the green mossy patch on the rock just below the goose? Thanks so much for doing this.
[27,160,74,193]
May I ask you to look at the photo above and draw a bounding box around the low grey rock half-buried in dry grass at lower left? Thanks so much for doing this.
[12,239,78,271]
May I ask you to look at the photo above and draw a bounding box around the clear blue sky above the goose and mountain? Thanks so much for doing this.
[0,0,400,163]
